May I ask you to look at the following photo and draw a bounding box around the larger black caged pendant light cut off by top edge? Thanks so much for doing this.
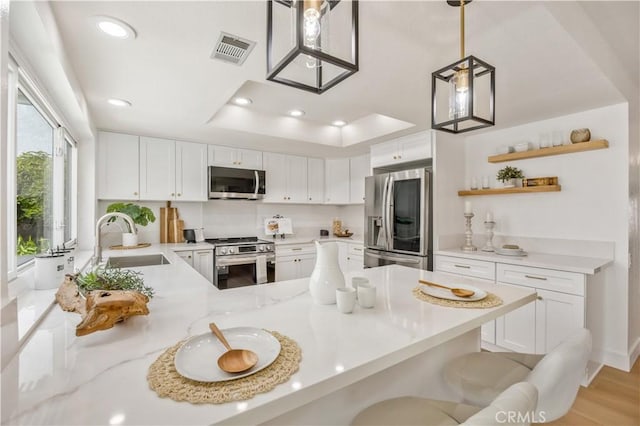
[267,0,358,94]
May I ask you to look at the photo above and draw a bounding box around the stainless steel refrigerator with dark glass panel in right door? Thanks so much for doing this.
[364,168,433,270]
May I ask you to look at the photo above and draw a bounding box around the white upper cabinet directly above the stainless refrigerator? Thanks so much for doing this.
[371,131,432,168]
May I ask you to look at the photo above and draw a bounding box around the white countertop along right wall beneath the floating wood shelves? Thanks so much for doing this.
[435,248,613,275]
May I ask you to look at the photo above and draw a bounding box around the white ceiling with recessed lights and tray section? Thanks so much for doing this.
[12,0,638,156]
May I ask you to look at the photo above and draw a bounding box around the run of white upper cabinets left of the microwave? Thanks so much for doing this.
[98,132,207,201]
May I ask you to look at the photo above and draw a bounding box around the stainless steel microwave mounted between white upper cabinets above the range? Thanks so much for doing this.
[209,166,265,200]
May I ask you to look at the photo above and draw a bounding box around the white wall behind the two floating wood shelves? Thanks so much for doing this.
[436,103,631,368]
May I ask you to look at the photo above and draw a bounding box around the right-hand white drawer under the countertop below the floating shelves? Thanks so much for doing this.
[497,263,585,296]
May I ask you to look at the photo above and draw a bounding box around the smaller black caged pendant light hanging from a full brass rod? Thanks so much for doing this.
[431,0,495,133]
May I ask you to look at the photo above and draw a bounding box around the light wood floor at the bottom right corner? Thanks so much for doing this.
[548,359,640,426]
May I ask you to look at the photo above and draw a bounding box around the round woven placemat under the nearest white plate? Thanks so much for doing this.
[147,331,302,404]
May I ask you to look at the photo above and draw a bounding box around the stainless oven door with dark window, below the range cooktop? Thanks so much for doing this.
[214,254,276,290]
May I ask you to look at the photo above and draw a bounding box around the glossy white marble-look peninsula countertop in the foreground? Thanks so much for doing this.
[2,255,535,425]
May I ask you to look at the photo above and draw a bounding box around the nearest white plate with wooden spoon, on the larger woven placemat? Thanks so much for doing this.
[174,327,280,382]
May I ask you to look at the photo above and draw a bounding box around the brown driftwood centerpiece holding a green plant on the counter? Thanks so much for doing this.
[56,269,153,336]
